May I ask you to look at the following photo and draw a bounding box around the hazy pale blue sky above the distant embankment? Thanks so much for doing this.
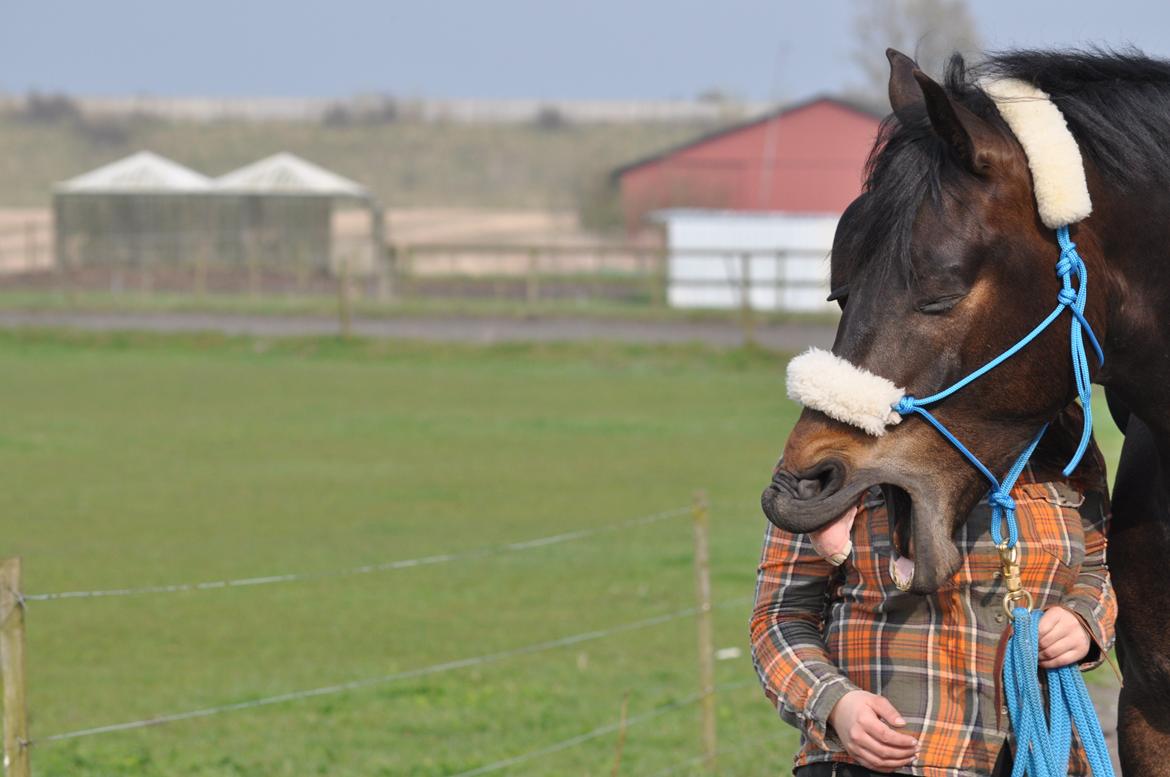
[0,0,1170,98]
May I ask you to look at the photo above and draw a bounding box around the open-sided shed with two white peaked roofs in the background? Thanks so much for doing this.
[53,151,384,273]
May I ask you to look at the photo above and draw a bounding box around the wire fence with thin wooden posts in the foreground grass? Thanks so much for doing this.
[0,497,767,777]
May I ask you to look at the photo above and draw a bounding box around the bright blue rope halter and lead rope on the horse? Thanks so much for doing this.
[893,226,1114,777]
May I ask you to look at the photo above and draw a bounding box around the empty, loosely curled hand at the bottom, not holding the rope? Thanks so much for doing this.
[828,690,918,771]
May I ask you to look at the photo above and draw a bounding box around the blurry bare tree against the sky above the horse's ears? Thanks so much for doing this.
[851,0,982,106]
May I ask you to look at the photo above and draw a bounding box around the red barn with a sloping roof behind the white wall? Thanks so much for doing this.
[613,97,881,229]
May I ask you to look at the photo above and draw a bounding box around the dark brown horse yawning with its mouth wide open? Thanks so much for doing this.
[762,49,1170,776]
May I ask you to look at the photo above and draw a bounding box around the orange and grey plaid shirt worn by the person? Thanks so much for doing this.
[751,473,1116,777]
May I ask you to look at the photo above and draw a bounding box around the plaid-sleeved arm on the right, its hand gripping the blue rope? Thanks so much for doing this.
[1060,491,1117,672]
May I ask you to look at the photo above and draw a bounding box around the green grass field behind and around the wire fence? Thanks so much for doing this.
[0,334,1115,777]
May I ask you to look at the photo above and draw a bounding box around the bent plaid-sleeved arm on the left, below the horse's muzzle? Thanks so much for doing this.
[751,514,858,750]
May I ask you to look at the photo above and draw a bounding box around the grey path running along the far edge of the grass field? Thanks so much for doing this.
[0,310,833,351]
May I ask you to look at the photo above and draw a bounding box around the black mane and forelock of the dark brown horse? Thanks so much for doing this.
[834,49,1170,286]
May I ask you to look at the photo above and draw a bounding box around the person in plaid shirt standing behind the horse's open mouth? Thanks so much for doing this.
[751,406,1116,777]
